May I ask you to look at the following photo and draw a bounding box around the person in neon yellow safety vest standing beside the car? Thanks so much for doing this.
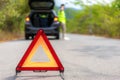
[58,4,66,39]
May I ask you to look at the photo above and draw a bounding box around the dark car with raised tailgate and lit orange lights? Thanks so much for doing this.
[25,0,60,40]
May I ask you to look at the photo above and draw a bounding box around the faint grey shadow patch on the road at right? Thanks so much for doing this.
[69,45,120,59]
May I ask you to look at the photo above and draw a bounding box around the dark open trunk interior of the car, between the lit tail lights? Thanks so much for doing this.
[30,12,54,28]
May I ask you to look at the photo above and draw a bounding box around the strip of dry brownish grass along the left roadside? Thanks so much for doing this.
[0,31,24,42]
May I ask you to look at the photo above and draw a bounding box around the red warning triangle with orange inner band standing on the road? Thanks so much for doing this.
[16,30,64,72]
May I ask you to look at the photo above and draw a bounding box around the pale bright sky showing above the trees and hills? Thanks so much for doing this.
[55,0,113,9]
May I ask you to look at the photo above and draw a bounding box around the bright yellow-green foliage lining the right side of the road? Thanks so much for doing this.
[67,0,120,38]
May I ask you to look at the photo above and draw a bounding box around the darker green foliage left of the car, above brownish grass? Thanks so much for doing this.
[0,0,29,32]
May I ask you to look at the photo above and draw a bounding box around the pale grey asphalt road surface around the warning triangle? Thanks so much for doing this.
[0,34,120,80]
